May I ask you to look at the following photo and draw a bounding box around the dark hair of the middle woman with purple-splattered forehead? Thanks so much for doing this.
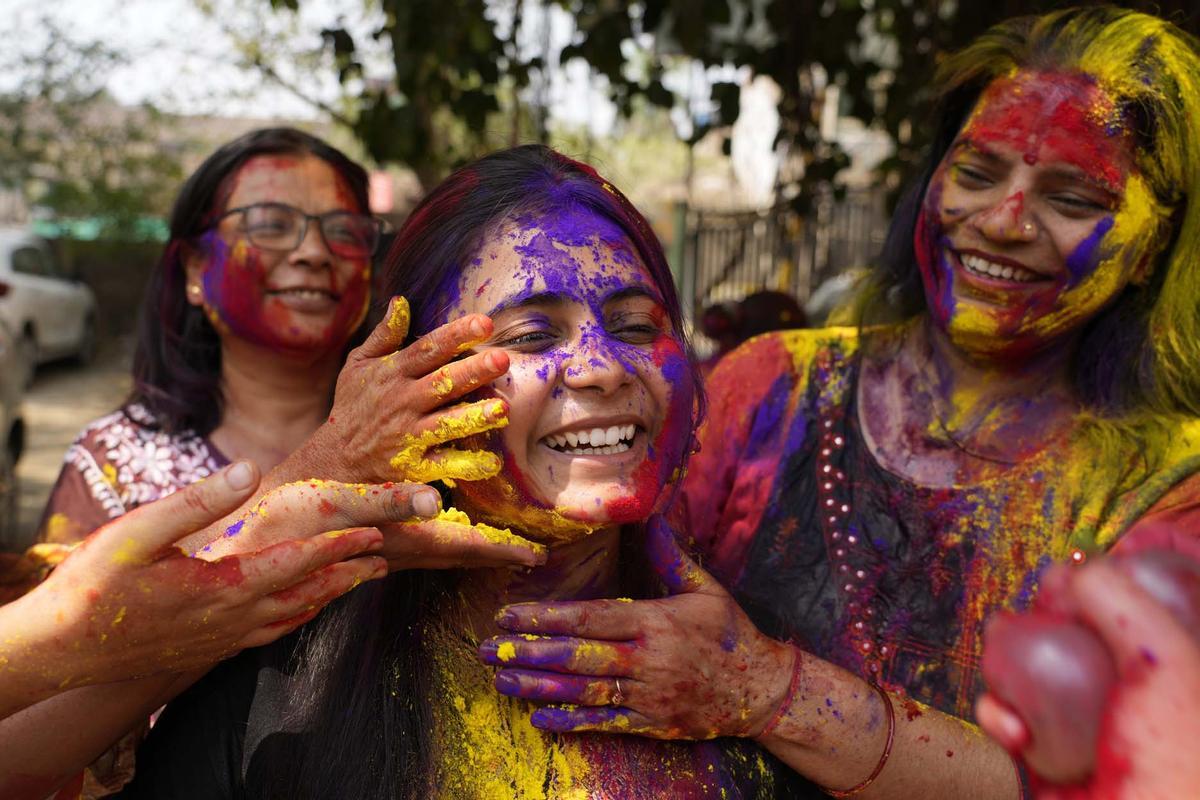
[247,145,700,800]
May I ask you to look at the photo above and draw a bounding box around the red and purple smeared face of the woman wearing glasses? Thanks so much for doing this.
[187,156,371,355]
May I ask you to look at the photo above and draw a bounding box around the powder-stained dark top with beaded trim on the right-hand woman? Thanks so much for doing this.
[680,329,1200,718]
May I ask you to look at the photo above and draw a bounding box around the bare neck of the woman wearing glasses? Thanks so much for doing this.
[210,339,341,473]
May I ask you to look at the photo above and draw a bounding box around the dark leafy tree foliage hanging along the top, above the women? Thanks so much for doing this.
[259,0,1200,204]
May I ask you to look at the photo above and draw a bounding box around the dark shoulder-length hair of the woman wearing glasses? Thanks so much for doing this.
[127,128,368,435]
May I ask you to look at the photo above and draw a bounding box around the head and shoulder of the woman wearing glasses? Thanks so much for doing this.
[42,128,380,542]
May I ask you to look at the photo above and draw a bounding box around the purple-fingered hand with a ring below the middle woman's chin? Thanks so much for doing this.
[479,517,794,739]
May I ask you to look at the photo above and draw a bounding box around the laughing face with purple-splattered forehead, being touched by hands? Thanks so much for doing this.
[445,210,694,541]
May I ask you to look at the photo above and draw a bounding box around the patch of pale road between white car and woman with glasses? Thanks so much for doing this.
[17,341,132,545]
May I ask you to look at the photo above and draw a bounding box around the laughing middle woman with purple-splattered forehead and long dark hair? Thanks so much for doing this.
[117,146,792,799]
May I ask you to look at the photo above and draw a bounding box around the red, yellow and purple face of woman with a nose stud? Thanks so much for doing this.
[913,72,1162,357]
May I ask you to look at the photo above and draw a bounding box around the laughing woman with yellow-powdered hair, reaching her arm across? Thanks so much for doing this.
[484,7,1200,800]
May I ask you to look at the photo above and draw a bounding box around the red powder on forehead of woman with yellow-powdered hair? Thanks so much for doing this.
[962,72,1130,192]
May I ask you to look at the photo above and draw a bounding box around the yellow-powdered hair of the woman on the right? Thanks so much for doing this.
[862,6,1200,420]
